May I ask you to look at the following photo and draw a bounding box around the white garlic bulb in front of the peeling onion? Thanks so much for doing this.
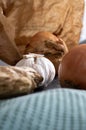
[16,53,56,87]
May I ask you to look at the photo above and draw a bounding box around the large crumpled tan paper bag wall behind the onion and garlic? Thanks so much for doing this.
[0,0,84,54]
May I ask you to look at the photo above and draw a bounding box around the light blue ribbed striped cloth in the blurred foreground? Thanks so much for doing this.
[0,88,86,130]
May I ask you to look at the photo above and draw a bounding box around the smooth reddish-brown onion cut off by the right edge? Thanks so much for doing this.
[58,43,86,90]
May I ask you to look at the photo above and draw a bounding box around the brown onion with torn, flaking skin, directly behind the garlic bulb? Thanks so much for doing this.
[25,32,68,73]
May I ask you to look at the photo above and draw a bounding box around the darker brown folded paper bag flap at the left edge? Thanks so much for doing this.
[0,8,22,65]
